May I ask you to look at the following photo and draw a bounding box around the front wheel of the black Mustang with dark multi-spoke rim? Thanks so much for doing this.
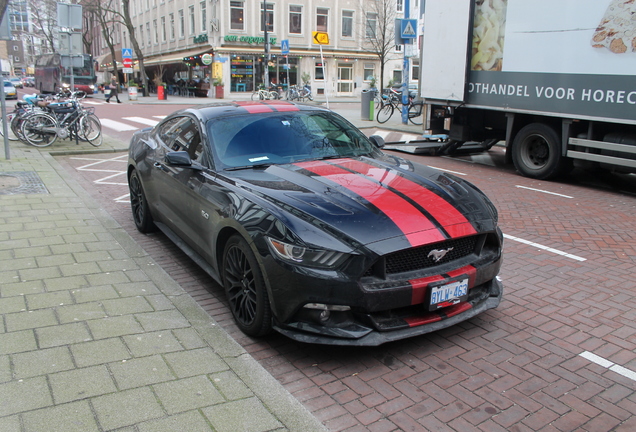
[223,235,272,337]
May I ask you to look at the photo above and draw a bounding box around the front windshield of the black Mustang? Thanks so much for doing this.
[208,111,376,168]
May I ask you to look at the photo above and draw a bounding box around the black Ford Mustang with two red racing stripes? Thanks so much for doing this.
[128,101,503,345]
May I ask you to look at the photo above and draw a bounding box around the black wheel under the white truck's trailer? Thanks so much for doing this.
[512,123,565,180]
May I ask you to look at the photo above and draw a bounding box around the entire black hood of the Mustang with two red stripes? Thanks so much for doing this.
[227,155,497,253]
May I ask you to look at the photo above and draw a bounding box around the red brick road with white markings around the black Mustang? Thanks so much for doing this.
[59,107,636,432]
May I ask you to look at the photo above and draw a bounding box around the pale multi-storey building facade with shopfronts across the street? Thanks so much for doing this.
[94,0,419,96]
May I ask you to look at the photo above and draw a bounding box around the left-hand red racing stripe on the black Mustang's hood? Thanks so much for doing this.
[295,160,445,246]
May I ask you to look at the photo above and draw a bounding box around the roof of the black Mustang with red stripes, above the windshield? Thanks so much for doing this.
[165,100,331,121]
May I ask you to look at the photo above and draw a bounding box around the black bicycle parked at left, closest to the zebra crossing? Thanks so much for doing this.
[21,91,102,147]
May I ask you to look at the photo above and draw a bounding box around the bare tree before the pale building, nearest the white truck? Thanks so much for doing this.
[358,0,397,91]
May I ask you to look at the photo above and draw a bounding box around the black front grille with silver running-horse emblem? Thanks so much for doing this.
[364,236,480,276]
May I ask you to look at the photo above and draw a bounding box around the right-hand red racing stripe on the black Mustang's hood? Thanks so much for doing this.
[339,160,477,238]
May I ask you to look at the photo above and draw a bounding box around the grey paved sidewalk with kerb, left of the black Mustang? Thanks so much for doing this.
[0,137,326,432]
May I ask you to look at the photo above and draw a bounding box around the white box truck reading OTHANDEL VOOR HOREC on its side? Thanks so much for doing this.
[420,0,636,179]
